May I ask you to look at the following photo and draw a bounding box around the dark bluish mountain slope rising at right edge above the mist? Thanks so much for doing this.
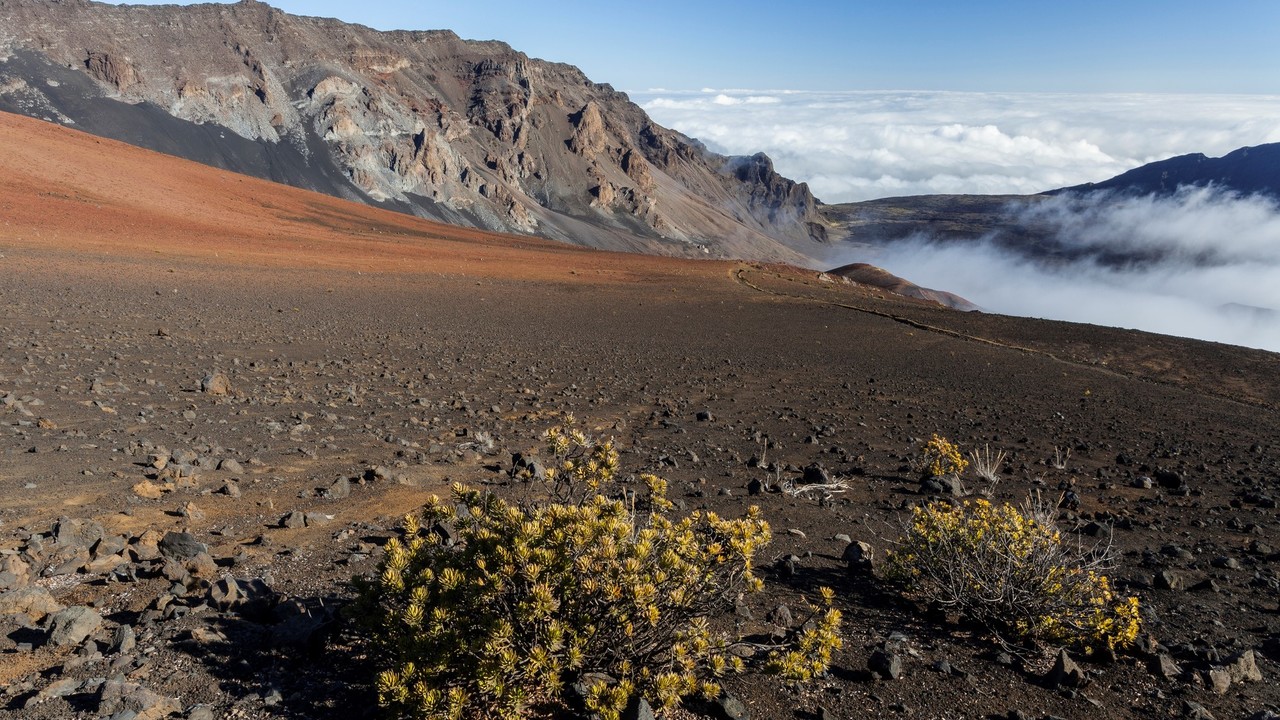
[1050,142,1280,200]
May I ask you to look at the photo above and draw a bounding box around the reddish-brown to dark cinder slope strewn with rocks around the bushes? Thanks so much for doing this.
[0,115,1280,719]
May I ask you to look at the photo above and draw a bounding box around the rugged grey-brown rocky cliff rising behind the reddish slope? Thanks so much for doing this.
[0,0,826,263]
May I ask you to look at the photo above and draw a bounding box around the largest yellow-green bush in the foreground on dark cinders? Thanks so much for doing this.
[357,427,840,719]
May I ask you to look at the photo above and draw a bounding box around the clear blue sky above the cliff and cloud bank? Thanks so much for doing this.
[112,0,1280,94]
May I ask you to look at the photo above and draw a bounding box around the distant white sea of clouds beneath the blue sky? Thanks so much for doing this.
[632,88,1280,202]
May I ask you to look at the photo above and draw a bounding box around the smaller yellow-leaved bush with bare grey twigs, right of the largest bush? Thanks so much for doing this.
[884,491,1139,652]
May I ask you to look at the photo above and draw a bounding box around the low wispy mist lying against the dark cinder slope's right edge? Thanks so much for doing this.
[836,188,1280,351]
